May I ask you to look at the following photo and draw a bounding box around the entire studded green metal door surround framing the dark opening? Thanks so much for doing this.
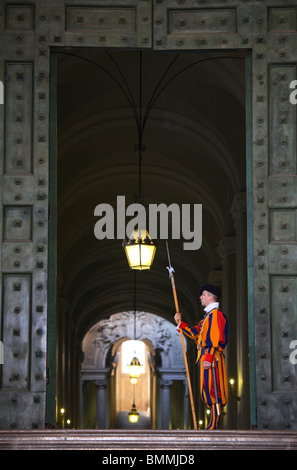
[0,0,297,429]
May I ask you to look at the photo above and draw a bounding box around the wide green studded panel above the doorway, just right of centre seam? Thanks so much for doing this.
[153,0,252,51]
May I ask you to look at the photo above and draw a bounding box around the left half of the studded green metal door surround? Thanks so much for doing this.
[0,0,151,429]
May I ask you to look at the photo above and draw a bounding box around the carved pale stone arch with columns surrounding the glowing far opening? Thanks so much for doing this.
[81,311,187,428]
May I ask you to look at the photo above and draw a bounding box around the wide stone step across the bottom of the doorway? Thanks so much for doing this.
[0,429,297,452]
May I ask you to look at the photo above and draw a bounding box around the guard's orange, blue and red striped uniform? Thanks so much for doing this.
[177,308,229,429]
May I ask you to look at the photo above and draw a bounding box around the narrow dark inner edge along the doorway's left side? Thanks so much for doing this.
[45,54,57,425]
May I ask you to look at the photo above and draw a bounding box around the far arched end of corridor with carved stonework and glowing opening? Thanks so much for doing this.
[81,312,187,429]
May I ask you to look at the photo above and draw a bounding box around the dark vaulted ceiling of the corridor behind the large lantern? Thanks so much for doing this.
[57,49,245,339]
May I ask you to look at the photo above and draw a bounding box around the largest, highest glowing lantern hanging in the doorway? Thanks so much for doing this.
[123,230,156,271]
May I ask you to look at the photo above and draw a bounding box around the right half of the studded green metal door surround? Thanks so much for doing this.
[153,0,297,429]
